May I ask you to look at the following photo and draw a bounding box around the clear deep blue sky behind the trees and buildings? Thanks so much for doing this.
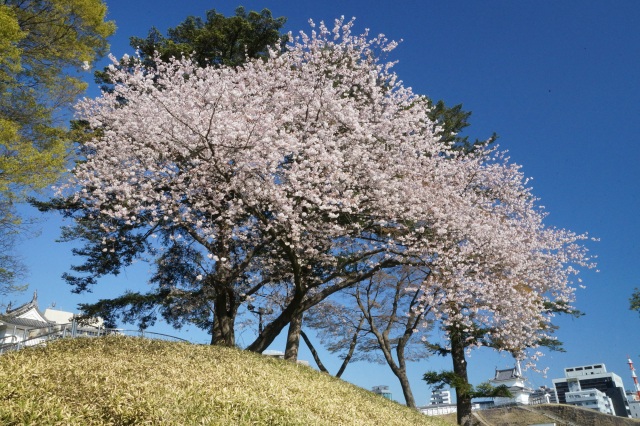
[10,0,640,405]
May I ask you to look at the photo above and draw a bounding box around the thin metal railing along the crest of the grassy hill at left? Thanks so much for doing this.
[0,321,191,354]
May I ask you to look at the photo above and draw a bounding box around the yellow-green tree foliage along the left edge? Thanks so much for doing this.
[0,0,115,292]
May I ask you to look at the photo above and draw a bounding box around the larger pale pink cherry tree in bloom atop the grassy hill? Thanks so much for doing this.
[52,18,450,350]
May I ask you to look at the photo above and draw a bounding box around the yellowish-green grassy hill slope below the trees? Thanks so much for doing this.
[0,337,446,426]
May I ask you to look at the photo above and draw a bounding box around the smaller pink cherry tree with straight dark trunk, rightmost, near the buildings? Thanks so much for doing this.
[416,151,594,424]
